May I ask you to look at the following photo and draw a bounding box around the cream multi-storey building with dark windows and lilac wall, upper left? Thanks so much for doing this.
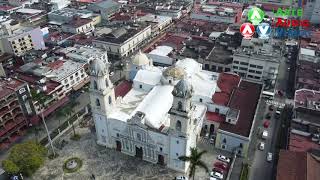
[0,25,46,56]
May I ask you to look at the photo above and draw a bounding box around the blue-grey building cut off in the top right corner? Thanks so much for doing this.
[303,0,320,24]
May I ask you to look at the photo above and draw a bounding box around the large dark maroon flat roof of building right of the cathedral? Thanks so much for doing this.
[220,80,262,137]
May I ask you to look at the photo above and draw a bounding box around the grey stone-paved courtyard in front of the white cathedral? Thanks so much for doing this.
[32,128,228,180]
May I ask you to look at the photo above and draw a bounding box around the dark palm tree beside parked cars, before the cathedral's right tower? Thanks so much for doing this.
[179,148,209,180]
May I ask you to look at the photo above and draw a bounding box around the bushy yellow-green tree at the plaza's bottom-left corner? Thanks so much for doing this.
[2,141,47,176]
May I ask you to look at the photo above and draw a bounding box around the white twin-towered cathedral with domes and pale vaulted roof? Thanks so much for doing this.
[90,53,222,172]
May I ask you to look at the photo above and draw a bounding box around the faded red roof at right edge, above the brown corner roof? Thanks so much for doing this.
[289,133,320,152]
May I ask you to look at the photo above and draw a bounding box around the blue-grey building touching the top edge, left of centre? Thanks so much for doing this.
[87,0,120,20]
